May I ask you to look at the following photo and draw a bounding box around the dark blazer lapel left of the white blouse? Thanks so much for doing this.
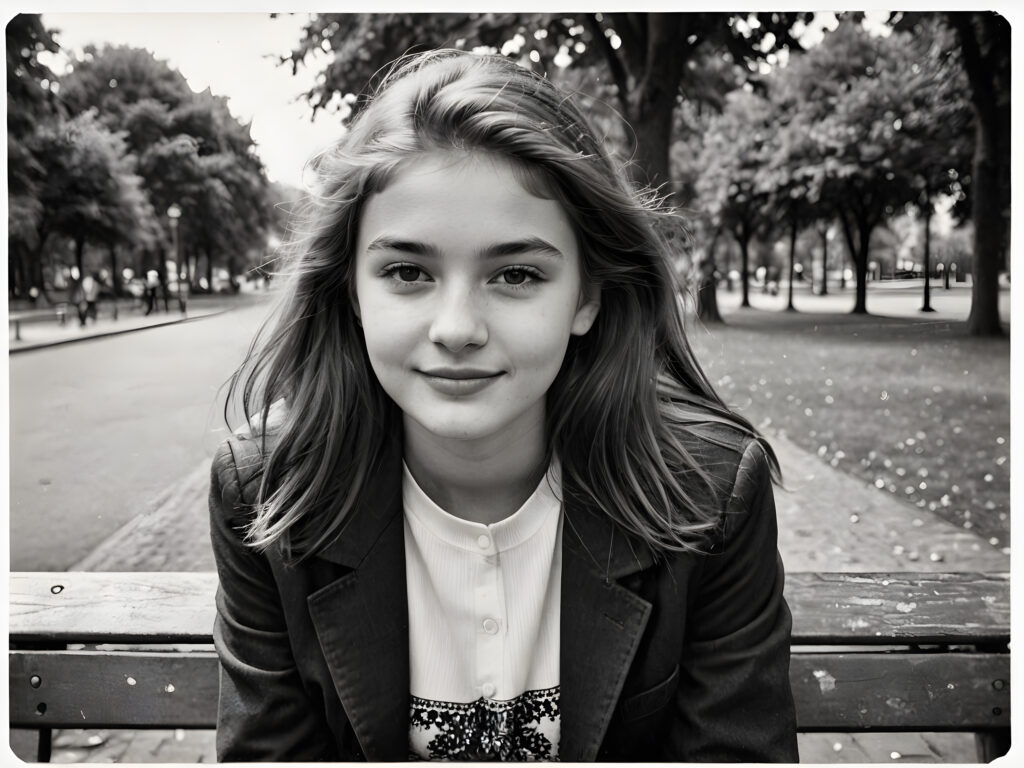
[307,441,410,762]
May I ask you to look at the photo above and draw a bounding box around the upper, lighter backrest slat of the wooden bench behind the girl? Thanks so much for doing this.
[9,571,1010,645]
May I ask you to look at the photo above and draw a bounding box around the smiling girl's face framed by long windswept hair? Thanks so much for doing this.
[355,153,598,449]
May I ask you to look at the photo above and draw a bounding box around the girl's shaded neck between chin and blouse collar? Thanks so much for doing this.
[404,414,548,524]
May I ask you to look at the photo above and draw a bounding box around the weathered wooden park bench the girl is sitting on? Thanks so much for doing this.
[9,571,1010,762]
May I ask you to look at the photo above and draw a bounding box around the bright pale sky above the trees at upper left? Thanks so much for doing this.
[37,12,340,186]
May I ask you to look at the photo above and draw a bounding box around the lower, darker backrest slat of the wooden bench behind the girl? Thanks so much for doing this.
[9,651,1010,732]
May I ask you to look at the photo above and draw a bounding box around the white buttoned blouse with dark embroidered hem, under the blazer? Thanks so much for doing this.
[402,461,562,761]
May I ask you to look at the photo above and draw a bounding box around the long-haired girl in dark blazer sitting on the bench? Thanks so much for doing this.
[210,51,797,762]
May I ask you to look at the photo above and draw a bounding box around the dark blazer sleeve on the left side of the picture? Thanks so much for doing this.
[210,438,334,762]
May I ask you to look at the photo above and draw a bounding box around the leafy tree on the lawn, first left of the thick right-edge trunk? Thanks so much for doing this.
[778,18,966,313]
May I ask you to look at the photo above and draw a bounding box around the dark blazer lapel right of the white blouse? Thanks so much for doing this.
[558,502,653,762]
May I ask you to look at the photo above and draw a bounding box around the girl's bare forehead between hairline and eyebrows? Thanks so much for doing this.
[358,152,575,252]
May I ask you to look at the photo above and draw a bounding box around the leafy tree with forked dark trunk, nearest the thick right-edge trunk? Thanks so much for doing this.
[762,19,967,312]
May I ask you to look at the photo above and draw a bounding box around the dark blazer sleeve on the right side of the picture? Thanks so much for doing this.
[669,440,799,763]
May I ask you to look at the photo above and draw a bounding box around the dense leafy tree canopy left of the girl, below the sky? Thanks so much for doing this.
[7,14,271,294]
